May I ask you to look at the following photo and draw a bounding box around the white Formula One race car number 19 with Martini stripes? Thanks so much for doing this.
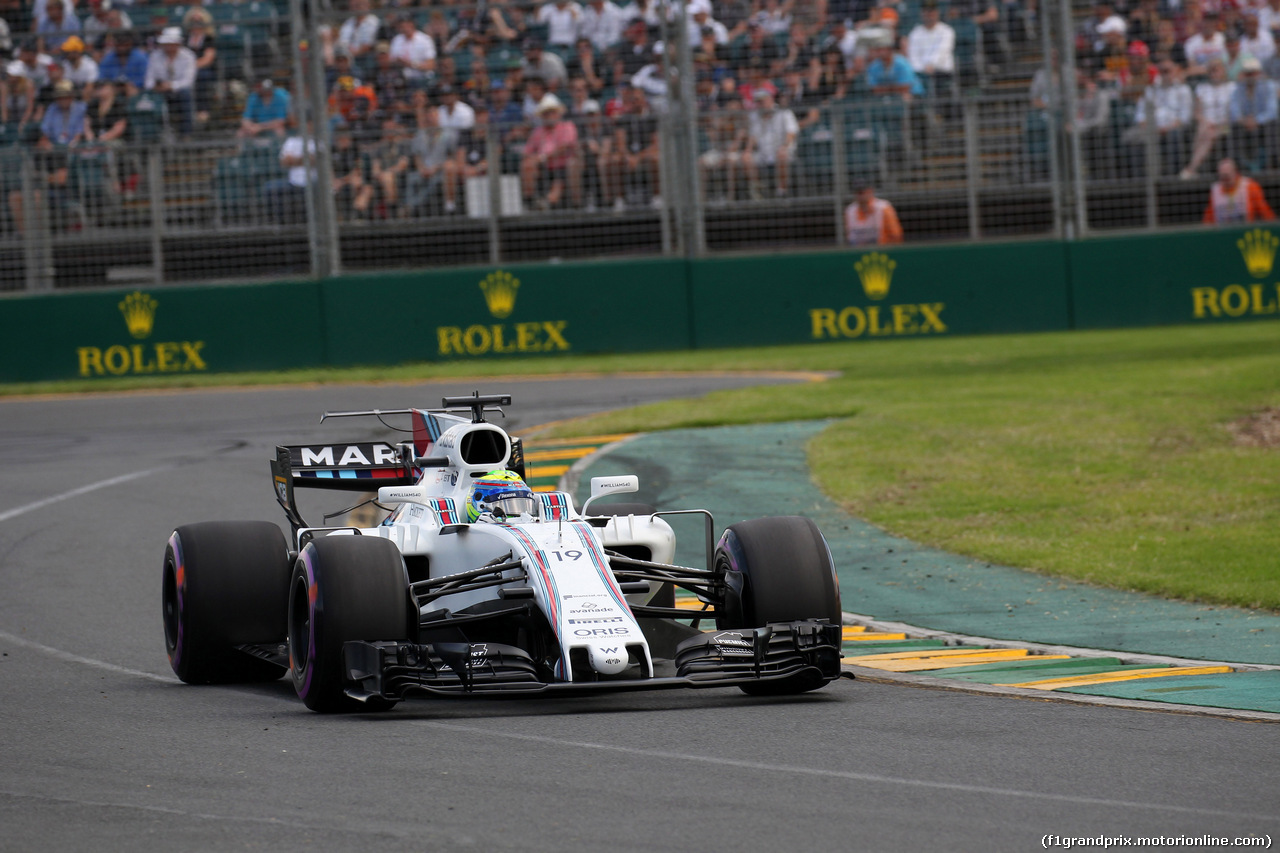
[163,392,841,711]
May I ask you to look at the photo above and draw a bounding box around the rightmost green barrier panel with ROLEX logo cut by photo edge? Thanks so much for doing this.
[1068,228,1280,329]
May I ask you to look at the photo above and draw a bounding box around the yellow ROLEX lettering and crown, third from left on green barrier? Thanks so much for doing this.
[809,252,947,341]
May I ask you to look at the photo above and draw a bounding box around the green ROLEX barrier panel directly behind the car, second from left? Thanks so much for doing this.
[320,253,692,366]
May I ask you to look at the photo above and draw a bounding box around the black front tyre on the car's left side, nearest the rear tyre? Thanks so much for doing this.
[288,535,416,713]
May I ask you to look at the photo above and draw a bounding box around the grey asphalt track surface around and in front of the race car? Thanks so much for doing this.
[0,377,1280,852]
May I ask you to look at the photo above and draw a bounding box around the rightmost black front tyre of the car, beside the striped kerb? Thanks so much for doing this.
[716,516,841,695]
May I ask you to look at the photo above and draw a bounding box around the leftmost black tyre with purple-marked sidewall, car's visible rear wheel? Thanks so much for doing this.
[161,521,289,684]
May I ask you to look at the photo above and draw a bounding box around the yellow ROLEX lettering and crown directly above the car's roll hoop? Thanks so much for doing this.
[435,269,570,356]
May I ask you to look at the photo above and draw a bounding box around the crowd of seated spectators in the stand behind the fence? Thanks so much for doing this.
[0,0,1280,229]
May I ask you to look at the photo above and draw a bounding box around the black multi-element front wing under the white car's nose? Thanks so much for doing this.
[343,621,841,701]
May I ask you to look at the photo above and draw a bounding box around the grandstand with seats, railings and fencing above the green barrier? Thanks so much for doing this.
[0,0,1280,291]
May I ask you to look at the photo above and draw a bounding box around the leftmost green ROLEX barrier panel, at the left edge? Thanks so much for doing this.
[0,282,323,382]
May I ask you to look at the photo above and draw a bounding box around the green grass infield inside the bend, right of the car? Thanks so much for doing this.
[542,324,1280,610]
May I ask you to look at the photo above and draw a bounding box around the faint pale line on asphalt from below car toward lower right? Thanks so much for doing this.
[415,720,1280,824]
